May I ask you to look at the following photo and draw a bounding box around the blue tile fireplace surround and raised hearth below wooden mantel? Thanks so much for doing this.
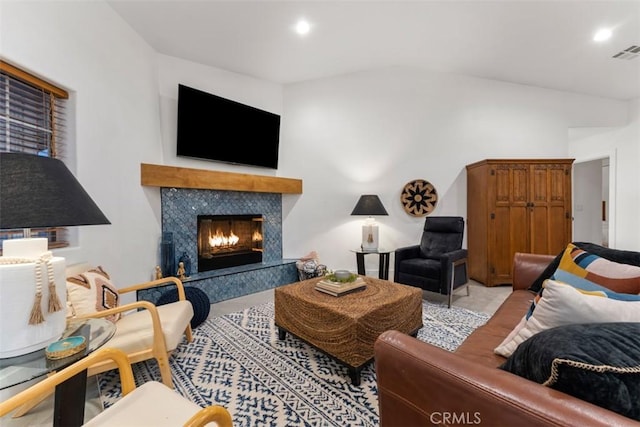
[138,187,298,303]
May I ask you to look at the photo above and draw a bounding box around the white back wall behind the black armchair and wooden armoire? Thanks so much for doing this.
[279,68,627,273]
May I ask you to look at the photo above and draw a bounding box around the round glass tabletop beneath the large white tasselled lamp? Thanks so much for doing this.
[0,319,116,390]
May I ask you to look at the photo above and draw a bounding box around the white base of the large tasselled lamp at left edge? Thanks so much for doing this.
[0,239,67,359]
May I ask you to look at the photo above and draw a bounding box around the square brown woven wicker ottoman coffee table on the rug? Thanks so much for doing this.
[274,277,422,385]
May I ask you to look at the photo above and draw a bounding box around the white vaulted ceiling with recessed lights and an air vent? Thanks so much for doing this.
[108,0,640,100]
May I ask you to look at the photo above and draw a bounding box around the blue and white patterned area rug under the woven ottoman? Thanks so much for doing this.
[98,301,489,427]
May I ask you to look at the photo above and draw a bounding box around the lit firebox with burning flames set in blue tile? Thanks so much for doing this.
[197,215,263,272]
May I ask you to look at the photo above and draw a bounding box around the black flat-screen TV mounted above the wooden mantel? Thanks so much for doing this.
[177,85,280,169]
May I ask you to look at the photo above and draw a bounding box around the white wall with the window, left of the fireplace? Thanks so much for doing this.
[0,1,161,294]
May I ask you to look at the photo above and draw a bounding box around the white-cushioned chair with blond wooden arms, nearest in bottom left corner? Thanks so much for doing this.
[0,348,232,427]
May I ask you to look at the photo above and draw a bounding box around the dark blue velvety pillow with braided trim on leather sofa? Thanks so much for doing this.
[500,323,640,421]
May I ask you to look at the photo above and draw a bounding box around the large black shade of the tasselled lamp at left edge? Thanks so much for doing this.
[0,153,110,229]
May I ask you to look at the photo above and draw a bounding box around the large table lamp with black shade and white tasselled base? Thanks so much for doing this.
[0,153,110,358]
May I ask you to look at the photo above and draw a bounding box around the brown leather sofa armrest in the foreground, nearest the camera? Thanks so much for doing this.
[374,331,638,427]
